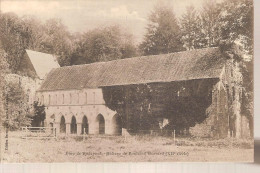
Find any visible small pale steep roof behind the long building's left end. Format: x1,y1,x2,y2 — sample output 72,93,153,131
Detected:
26,50,60,79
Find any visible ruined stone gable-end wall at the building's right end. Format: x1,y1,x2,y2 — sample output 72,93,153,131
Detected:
190,59,250,138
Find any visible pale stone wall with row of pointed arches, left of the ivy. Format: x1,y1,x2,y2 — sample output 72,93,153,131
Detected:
37,89,122,135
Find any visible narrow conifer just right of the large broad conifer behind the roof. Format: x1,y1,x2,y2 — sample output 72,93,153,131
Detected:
180,6,204,50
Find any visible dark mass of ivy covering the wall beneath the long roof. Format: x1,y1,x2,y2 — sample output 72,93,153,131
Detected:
102,79,216,133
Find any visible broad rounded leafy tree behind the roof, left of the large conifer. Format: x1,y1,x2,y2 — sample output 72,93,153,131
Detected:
71,26,136,64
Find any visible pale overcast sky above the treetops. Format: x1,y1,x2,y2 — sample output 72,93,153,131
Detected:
0,0,210,42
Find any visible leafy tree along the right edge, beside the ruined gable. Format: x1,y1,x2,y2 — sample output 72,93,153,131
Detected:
219,0,254,136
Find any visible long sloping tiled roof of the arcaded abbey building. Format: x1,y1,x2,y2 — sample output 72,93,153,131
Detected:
39,48,225,91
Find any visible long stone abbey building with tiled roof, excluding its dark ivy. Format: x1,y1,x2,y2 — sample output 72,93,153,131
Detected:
33,48,250,138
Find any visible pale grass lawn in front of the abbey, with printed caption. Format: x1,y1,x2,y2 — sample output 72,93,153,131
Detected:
1,132,254,163
